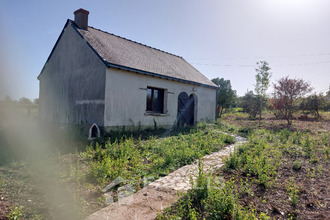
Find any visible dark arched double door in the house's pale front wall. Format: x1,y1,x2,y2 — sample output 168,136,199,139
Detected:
177,92,195,127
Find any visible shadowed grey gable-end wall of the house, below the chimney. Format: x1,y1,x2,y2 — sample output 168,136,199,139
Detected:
39,23,106,126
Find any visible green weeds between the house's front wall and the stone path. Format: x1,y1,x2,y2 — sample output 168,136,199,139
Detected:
81,128,234,185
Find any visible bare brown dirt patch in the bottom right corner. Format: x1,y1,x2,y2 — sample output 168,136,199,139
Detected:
221,152,330,220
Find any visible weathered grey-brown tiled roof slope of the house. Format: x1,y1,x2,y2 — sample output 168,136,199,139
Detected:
71,21,216,87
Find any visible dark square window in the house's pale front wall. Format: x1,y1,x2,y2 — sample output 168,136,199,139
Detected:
147,87,164,113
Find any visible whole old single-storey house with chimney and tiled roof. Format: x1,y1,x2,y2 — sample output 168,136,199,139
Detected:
38,9,217,137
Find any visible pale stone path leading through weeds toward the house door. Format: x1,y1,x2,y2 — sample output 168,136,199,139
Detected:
87,136,246,220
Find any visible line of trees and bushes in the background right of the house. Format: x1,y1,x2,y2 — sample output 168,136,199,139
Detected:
212,61,330,125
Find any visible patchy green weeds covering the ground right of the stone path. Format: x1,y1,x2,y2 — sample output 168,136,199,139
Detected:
157,123,330,219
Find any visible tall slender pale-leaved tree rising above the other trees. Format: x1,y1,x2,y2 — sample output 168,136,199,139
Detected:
254,61,272,126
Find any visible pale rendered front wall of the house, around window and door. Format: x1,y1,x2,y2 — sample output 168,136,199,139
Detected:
104,68,216,128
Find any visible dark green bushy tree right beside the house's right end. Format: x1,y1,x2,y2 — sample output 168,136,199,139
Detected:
212,77,237,118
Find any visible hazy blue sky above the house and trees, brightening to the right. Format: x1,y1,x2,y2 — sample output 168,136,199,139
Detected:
0,0,330,99
